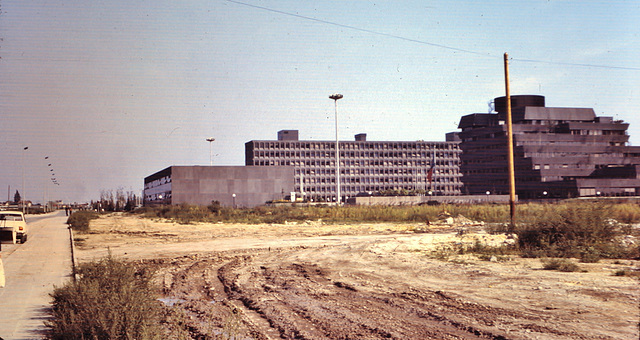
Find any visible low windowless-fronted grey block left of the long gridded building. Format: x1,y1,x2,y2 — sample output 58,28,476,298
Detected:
144,166,294,208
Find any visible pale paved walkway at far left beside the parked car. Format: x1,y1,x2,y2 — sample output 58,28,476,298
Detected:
0,211,71,340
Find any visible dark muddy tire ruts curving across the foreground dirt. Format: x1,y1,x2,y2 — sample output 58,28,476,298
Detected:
158,249,576,339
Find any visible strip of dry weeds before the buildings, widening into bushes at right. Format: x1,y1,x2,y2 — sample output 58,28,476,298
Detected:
138,202,640,263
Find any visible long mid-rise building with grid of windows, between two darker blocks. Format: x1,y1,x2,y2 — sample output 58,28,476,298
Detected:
245,130,462,202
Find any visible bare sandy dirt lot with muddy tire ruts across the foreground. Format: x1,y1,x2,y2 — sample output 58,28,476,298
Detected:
76,214,640,339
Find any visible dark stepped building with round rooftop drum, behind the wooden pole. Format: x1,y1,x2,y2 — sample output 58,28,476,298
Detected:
449,95,640,198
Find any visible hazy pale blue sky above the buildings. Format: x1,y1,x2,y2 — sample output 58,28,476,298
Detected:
0,0,640,201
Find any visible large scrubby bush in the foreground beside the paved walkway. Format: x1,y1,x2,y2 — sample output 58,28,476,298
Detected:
45,257,164,340
